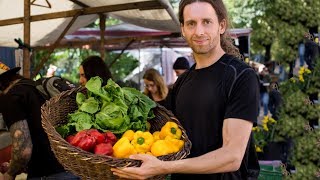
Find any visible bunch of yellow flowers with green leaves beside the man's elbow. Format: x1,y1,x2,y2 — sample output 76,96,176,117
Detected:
252,116,277,152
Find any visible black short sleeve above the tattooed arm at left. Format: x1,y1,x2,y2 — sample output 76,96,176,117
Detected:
2,95,27,128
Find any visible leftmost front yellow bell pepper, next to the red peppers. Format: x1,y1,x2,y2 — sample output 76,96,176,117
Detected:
113,137,137,158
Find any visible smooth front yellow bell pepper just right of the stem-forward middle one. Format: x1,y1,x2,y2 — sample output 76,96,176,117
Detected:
151,140,174,156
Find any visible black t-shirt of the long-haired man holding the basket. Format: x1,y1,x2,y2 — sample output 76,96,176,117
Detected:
172,55,259,180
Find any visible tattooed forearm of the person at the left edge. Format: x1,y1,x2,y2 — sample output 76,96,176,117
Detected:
7,120,32,176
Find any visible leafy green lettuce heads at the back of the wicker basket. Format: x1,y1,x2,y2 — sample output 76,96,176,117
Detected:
56,77,156,137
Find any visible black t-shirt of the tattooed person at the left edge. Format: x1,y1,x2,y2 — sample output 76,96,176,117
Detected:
1,79,64,178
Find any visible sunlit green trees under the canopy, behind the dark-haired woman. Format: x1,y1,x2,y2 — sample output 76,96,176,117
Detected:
32,48,139,83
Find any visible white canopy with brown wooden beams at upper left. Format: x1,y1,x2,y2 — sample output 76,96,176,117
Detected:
0,0,179,77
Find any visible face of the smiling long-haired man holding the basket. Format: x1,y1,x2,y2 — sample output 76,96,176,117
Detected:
181,2,226,54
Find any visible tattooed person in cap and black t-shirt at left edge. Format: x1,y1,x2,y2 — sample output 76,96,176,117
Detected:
0,62,79,179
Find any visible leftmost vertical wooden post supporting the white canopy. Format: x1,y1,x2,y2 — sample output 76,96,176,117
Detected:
23,0,30,78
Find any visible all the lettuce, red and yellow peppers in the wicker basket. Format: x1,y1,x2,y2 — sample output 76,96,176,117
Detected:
56,77,184,158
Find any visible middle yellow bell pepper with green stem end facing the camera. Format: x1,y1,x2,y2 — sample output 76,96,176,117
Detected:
131,131,153,153
